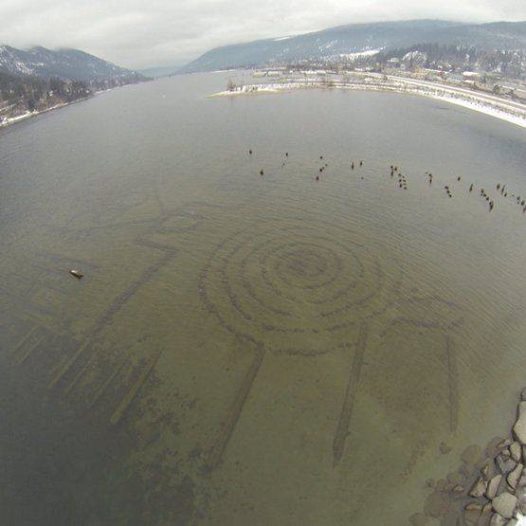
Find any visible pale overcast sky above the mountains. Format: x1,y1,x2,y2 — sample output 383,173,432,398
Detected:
0,0,526,68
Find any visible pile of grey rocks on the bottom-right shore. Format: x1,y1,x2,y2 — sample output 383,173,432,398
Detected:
410,389,526,526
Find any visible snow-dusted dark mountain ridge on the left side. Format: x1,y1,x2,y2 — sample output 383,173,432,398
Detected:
0,45,146,84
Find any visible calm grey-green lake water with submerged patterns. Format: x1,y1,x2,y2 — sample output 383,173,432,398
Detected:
0,74,526,526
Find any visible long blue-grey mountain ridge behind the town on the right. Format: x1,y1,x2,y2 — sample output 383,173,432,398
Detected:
179,20,526,73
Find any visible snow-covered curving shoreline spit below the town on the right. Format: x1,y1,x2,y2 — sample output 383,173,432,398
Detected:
212,75,526,128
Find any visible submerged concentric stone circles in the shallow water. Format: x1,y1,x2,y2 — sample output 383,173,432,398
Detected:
200,218,400,355
